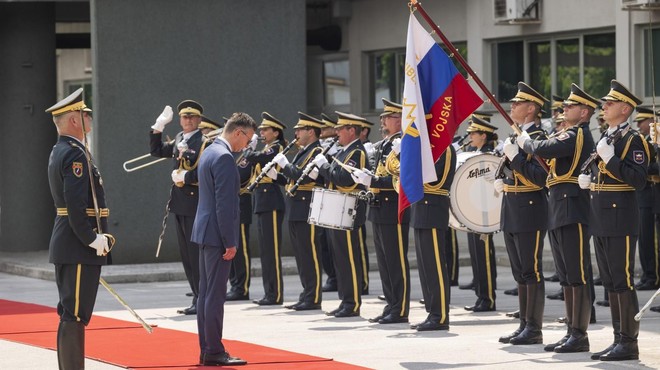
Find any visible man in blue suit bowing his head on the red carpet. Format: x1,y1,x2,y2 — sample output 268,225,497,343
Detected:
192,113,257,366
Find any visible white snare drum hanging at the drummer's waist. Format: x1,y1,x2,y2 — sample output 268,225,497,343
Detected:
307,188,357,230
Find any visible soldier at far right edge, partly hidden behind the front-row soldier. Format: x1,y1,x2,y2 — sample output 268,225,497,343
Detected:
633,107,660,290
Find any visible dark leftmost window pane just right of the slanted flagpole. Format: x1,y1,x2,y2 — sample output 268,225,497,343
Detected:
496,41,525,102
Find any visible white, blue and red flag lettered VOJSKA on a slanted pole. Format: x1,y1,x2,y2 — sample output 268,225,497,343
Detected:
399,13,483,218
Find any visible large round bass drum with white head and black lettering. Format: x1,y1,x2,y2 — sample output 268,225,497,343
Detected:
449,152,502,234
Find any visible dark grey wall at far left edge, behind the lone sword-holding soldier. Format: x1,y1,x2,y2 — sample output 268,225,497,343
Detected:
0,2,57,252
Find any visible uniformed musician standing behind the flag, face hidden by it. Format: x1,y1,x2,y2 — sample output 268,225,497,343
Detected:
385,132,456,331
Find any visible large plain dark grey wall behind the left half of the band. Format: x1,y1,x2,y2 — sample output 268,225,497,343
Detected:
91,0,306,263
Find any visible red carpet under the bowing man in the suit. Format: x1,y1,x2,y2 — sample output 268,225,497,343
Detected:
0,300,364,370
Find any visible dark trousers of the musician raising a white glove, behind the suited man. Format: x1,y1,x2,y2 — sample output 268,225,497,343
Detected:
176,215,199,304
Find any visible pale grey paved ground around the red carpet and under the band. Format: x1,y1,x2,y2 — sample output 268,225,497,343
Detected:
0,250,660,370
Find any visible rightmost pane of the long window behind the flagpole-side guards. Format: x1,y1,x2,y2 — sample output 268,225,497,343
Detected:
582,33,616,99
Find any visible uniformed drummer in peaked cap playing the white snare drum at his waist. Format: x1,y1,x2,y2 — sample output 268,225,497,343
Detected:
312,112,370,317
